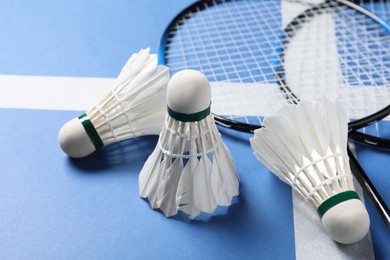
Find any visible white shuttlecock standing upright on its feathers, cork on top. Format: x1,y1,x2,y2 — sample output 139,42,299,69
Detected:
139,70,239,219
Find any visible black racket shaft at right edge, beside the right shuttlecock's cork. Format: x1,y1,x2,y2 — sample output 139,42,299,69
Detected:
347,147,390,228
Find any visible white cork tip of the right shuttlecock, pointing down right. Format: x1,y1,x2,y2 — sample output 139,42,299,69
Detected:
322,199,370,244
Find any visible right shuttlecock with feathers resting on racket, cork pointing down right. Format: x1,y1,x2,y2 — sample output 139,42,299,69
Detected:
250,98,370,244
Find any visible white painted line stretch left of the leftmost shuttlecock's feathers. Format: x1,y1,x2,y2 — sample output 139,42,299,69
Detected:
0,75,115,111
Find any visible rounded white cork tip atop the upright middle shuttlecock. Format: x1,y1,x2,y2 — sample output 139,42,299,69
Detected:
167,70,211,114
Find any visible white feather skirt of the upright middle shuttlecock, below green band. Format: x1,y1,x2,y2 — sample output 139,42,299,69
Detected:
139,116,239,219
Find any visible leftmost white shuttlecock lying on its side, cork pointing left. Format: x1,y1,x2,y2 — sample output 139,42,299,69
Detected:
58,48,169,158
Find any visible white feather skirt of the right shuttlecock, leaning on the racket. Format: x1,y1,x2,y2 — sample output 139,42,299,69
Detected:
251,98,351,206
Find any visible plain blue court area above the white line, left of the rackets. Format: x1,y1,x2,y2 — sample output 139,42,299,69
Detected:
0,0,192,77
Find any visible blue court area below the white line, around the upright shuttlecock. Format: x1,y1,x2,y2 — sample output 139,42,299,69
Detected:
0,109,294,259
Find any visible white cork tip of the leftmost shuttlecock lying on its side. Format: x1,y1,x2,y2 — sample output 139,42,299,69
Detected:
58,118,96,158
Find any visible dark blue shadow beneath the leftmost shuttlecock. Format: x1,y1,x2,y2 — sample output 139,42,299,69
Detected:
69,136,158,172
